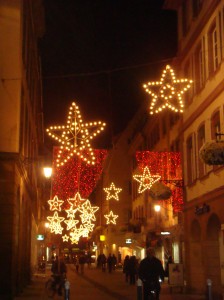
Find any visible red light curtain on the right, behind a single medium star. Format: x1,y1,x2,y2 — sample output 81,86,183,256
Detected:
136,151,183,213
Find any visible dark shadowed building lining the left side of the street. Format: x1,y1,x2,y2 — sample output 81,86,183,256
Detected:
0,0,44,299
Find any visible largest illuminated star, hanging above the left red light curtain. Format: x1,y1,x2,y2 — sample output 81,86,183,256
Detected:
47,102,106,167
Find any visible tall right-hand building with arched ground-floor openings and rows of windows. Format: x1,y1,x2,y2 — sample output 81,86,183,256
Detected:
164,0,224,299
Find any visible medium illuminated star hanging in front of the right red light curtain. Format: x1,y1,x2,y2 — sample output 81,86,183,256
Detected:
133,167,161,193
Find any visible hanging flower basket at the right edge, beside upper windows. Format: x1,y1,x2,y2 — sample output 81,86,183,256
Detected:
199,140,224,165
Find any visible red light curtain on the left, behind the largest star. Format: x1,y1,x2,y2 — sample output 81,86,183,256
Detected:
52,147,108,203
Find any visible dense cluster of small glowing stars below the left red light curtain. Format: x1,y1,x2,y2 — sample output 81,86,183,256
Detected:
47,193,99,244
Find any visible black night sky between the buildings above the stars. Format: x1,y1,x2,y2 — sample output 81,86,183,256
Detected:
40,0,176,147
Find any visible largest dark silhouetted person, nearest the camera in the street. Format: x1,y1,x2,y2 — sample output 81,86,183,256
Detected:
138,248,165,300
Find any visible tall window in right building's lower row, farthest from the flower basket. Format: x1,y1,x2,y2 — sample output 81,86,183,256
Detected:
187,135,196,184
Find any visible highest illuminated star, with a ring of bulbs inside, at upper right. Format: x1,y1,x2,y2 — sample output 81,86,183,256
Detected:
143,65,193,114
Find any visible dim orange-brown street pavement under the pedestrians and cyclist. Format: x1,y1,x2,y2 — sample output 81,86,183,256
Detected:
15,264,205,300
